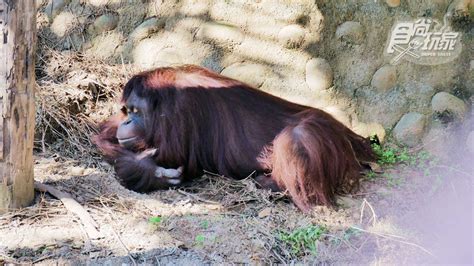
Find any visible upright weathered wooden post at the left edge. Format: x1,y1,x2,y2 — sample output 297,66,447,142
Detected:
0,0,36,213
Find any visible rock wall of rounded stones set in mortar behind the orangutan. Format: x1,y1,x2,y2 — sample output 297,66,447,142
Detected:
37,0,474,150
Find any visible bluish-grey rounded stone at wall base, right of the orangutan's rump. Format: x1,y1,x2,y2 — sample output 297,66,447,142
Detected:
393,112,426,147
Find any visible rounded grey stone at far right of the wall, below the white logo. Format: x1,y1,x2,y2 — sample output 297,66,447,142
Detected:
431,91,467,119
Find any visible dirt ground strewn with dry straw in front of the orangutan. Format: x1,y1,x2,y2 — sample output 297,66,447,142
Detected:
0,143,472,265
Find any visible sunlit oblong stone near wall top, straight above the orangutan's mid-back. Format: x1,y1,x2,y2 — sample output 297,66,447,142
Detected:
196,22,244,44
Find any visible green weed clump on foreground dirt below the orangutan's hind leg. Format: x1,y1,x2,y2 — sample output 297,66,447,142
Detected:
278,225,327,255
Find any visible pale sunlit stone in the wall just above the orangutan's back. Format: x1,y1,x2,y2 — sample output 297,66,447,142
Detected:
221,62,269,88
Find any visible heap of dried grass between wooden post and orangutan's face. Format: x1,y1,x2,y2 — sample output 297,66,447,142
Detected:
35,42,133,160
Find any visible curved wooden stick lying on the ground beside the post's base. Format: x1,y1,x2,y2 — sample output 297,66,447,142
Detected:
35,182,103,239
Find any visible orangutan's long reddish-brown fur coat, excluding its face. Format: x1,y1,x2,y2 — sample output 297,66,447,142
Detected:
94,66,374,211
